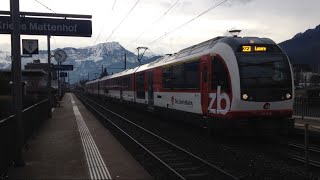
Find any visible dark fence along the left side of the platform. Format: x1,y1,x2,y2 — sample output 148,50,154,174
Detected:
0,99,49,179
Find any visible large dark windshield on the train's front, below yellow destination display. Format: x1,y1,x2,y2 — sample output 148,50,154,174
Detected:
237,53,292,101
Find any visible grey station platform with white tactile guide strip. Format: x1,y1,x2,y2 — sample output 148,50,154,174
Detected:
8,93,152,179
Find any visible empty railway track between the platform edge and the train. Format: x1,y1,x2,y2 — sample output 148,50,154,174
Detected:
76,94,238,179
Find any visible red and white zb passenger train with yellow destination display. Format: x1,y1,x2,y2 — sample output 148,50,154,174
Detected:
84,36,294,130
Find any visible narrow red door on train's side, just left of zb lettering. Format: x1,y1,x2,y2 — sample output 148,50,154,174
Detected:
200,58,209,115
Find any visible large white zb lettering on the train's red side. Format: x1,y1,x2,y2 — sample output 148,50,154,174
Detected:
208,86,230,115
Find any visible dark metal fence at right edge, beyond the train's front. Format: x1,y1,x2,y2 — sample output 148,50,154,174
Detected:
293,97,320,117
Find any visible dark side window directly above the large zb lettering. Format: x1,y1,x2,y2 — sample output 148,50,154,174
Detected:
211,57,230,93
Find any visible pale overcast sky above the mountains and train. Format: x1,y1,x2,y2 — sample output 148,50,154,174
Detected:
0,0,320,54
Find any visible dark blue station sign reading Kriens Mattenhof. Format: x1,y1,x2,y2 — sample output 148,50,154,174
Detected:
0,16,92,37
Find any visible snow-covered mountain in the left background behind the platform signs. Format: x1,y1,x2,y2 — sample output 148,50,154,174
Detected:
0,42,159,83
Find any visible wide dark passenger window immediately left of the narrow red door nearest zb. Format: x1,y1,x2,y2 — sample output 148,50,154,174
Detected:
162,61,200,89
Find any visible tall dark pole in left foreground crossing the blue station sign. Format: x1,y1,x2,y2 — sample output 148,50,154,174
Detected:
10,0,25,166
